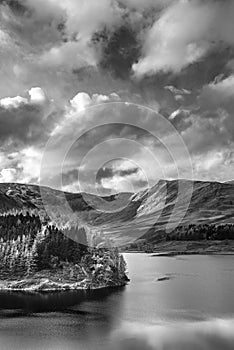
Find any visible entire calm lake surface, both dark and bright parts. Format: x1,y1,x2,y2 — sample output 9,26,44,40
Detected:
0,254,234,350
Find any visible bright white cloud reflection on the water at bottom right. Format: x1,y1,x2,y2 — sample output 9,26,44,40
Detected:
113,319,234,350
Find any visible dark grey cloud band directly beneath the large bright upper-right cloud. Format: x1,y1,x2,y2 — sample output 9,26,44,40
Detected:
136,45,234,108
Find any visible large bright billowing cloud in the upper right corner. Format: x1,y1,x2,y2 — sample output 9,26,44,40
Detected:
133,0,234,76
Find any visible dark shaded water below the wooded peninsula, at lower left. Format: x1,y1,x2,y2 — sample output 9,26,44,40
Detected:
0,287,125,350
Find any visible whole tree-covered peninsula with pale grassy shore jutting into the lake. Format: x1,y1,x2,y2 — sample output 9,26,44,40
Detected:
0,212,128,292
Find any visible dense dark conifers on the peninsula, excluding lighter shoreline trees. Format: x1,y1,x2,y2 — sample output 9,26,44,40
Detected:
0,213,87,276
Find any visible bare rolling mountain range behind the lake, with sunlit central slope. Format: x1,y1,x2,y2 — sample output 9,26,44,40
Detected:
0,180,234,244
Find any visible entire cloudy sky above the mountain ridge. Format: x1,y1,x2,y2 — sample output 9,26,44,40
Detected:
0,0,234,195
